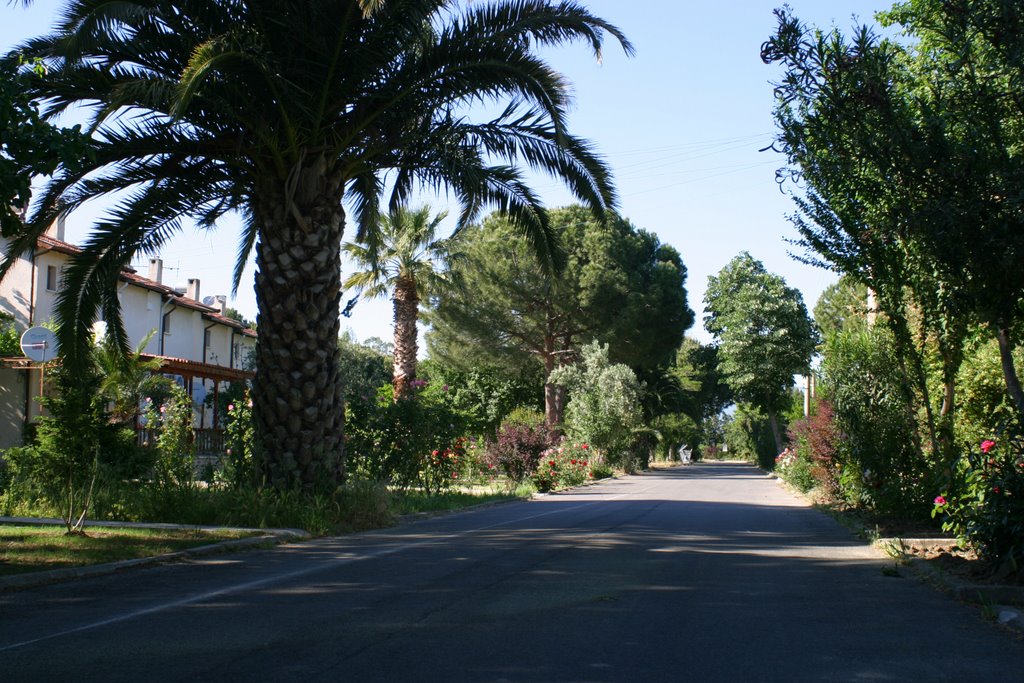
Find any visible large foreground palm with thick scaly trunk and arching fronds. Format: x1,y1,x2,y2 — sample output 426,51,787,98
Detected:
0,0,632,489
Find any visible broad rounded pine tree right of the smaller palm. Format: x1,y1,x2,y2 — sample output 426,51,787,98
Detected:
427,206,693,428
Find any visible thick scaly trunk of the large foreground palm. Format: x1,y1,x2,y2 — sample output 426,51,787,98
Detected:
252,169,345,492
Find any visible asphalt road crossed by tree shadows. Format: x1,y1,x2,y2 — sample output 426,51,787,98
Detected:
0,463,1024,683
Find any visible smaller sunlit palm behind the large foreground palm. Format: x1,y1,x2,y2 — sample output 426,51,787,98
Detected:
343,205,463,400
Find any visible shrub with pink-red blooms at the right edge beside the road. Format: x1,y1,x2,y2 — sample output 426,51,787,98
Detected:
932,424,1024,572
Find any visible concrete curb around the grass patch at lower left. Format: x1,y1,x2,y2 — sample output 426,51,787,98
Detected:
0,517,312,592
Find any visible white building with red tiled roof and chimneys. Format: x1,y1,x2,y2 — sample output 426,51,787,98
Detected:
0,223,256,451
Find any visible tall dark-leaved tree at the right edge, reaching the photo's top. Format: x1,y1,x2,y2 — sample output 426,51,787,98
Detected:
763,0,1024,428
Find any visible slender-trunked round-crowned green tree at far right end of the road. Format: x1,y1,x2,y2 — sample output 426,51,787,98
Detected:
703,252,818,453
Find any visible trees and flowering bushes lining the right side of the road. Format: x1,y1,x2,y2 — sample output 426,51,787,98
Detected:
757,0,1024,580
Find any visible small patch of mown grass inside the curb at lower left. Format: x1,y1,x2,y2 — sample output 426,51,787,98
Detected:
0,525,258,577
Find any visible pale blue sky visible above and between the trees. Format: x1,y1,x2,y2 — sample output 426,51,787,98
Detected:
0,0,889,348
